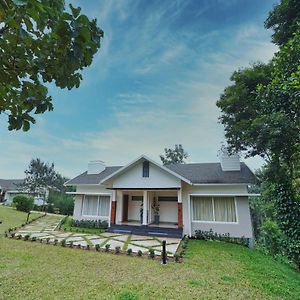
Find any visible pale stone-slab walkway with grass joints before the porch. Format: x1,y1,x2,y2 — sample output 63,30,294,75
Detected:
16,215,180,256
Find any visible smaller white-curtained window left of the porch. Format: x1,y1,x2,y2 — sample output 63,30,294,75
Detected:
82,195,110,217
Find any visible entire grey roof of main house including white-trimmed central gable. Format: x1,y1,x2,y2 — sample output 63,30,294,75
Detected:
65,155,256,186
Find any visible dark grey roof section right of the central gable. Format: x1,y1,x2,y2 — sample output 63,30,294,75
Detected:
166,163,256,184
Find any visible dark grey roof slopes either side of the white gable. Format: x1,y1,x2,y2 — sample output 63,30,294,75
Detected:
66,163,256,185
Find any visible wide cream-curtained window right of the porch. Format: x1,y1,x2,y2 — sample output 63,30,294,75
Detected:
192,196,237,223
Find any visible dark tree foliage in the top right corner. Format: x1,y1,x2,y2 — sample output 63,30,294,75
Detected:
265,0,300,46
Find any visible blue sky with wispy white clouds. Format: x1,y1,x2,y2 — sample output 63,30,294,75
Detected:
0,0,278,178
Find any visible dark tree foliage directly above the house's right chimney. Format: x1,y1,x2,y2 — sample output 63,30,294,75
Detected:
217,63,271,156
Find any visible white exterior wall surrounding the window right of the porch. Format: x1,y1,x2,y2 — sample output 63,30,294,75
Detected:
182,184,253,238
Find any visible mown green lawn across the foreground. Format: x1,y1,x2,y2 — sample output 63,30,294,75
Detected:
0,207,300,300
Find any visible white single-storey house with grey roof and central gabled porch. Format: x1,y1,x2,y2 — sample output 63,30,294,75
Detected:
65,155,256,238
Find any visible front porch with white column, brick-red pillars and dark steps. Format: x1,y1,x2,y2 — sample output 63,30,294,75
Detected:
109,188,183,237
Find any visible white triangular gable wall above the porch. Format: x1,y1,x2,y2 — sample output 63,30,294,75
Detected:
113,163,181,189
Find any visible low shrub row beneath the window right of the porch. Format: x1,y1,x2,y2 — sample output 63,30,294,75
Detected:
194,229,248,246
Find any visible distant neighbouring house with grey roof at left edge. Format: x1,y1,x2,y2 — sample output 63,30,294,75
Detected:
0,179,43,206
